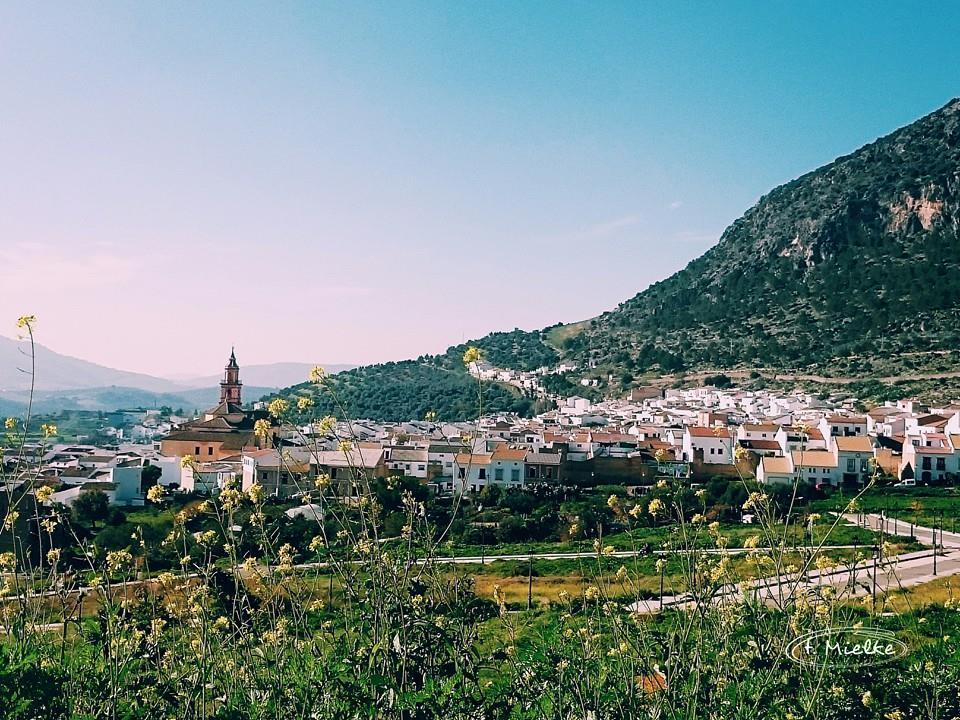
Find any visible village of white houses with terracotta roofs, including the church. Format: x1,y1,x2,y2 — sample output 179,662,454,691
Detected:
6,354,960,507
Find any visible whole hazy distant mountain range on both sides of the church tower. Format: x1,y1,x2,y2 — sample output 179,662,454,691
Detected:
0,336,351,416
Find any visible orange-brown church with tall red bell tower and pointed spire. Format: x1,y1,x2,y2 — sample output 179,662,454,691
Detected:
160,348,276,462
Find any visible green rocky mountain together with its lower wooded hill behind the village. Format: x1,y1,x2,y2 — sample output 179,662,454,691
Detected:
268,99,960,420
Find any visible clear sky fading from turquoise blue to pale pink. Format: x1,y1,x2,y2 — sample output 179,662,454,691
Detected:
0,0,960,376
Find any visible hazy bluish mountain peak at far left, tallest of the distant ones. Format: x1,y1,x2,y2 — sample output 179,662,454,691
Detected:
0,336,183,393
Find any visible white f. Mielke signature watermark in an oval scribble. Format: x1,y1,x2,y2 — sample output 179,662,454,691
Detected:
786,627,909,668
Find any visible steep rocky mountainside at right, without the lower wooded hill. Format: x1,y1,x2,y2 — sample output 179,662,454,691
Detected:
568,100,960,369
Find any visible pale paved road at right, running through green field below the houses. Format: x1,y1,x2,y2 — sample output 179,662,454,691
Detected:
631,514,960,613
